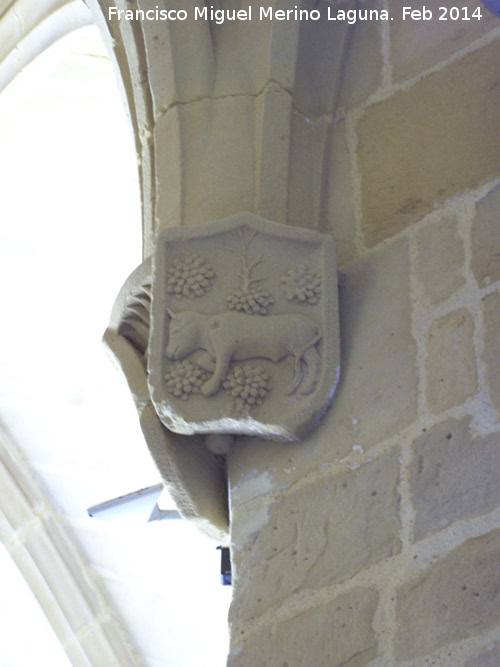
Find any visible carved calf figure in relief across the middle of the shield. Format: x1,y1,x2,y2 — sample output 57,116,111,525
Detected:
165,311,322,396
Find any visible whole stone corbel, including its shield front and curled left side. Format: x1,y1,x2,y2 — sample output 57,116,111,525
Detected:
104,213,339,542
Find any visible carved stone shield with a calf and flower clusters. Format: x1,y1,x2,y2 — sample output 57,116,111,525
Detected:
149,213,340,440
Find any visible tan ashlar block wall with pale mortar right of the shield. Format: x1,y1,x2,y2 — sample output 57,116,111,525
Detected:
228,6,500,667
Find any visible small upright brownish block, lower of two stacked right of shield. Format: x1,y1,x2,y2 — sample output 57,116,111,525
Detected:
427,308,477,414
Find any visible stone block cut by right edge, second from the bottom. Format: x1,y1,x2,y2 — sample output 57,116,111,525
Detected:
396,530,500,660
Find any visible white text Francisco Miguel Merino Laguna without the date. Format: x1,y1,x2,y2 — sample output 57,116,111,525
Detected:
108,5,390,24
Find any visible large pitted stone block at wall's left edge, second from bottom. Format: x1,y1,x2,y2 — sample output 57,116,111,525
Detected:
231,452,400,620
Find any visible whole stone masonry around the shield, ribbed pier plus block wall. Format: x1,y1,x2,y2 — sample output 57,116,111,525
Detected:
88,0,500,667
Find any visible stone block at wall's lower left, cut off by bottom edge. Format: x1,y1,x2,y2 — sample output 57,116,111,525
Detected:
228,588,378,667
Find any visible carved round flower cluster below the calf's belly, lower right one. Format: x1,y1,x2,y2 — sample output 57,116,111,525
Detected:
222,364,271,414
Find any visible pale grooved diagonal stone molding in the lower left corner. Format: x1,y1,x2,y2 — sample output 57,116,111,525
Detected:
0,426,139,667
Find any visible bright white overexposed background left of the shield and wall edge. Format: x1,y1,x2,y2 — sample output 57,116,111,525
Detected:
0,27,230,667
